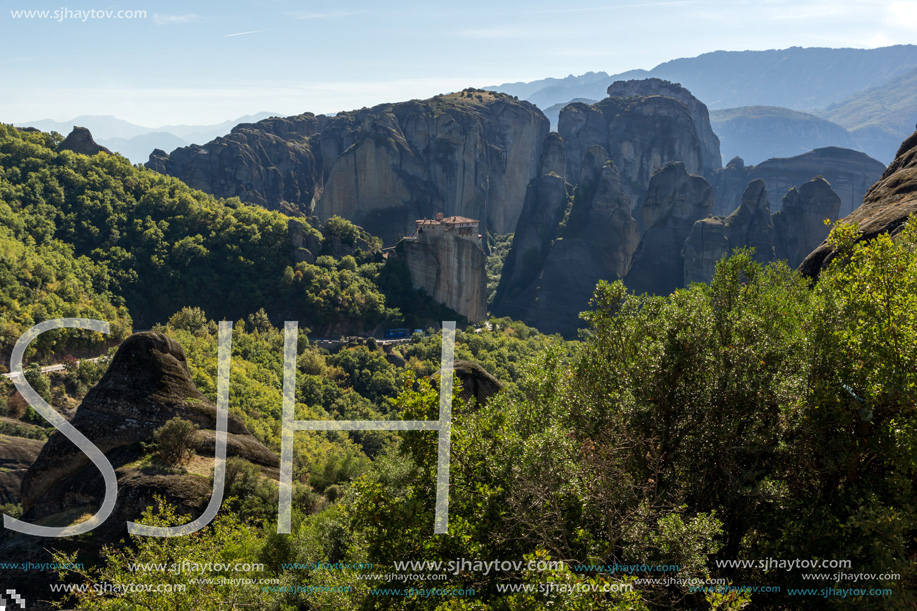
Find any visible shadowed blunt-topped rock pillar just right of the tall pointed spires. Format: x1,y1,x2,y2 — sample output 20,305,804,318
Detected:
624,163,713,295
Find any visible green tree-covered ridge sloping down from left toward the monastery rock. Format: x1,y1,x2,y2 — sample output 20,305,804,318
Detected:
0,126,446,364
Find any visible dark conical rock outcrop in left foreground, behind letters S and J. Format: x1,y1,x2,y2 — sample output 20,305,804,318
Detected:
22,332,279,533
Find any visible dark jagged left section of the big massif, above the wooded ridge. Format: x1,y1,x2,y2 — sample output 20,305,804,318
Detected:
146,113,328,214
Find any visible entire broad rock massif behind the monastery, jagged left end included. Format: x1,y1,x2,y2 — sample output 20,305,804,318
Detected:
147,90,548,244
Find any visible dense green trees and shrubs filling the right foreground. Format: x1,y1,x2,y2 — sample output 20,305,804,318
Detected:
52,221,917,610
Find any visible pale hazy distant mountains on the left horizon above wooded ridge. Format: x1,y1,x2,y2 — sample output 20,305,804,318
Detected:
16,112,277,163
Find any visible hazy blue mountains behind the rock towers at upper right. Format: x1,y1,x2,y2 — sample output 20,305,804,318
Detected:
486,45,917,164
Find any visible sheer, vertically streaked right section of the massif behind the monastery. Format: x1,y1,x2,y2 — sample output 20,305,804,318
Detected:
315,90,548,242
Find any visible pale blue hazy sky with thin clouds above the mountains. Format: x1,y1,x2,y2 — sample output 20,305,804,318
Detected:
0,0,917,127
